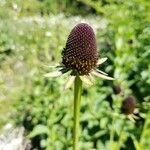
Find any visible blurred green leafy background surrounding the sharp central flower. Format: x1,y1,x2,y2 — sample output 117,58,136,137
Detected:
0,0,150,150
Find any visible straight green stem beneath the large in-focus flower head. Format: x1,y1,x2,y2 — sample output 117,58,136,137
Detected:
73,76,82,150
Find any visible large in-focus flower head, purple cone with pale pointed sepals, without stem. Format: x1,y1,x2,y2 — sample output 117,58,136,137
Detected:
45,23,113,88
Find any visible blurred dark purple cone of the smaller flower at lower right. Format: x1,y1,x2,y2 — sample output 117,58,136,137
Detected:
121,96,136,115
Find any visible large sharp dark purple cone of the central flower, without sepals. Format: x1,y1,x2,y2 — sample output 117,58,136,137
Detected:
62,23,98,75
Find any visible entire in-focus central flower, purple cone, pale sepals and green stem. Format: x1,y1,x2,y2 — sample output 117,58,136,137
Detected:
44,23,114,150
